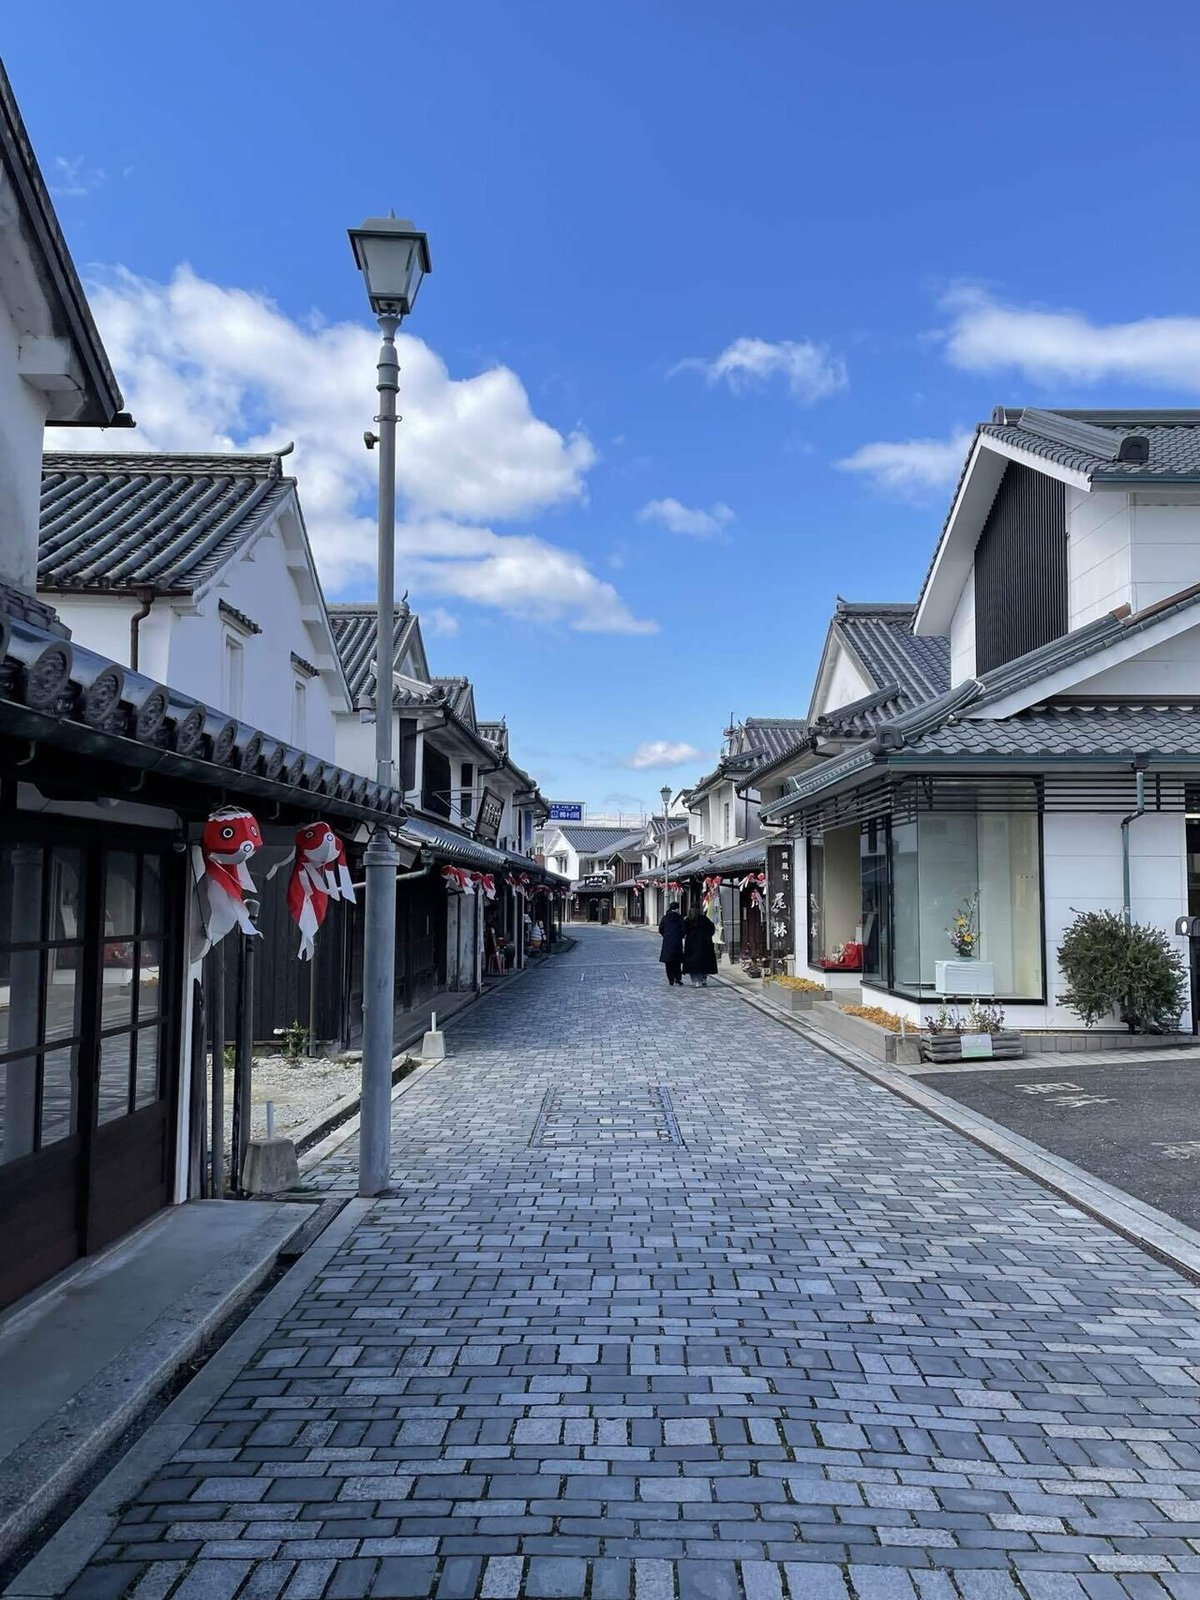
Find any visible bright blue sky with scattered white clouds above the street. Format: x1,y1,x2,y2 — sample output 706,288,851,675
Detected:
5,0,1200,810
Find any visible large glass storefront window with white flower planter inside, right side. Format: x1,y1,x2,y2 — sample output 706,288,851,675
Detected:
808,797,1045,1003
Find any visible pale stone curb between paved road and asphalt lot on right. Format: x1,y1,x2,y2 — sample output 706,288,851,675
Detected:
722,982,1200,1282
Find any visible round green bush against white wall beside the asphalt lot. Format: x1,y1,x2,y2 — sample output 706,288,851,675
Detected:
1058,910,1187,1034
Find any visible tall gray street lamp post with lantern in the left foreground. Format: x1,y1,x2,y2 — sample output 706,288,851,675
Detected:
350,216,430,1197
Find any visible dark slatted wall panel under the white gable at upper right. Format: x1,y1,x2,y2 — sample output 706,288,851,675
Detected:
974,461,1067,672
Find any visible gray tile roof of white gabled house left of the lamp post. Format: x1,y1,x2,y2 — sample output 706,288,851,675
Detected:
37,453,296,594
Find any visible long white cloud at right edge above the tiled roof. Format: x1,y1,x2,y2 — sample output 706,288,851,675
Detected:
944,286,1200,392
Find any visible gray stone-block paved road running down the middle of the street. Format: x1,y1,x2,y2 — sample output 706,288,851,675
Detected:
56,928,1200,1600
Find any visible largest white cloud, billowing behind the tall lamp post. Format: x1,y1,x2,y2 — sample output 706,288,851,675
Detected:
48,266,654,634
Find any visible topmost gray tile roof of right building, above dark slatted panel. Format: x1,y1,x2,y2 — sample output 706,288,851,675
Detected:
979,406,1200,483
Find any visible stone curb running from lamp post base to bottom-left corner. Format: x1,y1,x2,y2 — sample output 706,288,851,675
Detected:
5,1200,374,1600
